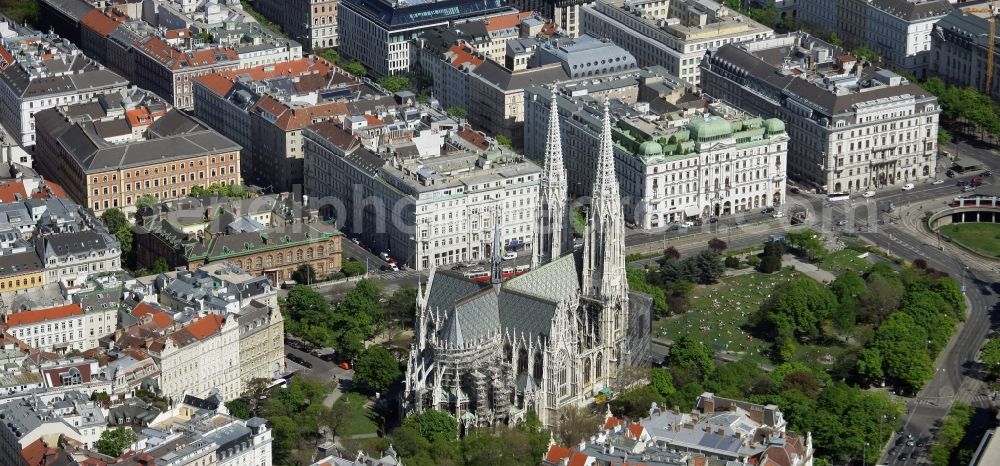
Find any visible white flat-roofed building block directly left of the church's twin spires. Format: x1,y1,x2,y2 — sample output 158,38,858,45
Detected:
305,121,540,270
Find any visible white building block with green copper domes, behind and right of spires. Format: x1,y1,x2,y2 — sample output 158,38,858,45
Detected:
525,73,789,229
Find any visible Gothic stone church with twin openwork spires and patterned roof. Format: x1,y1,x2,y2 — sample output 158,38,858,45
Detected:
403,96,651,429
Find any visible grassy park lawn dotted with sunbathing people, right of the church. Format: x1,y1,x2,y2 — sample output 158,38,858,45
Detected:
653,269,797,356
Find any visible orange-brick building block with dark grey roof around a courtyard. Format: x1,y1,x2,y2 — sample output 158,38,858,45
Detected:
35,90,242,213
